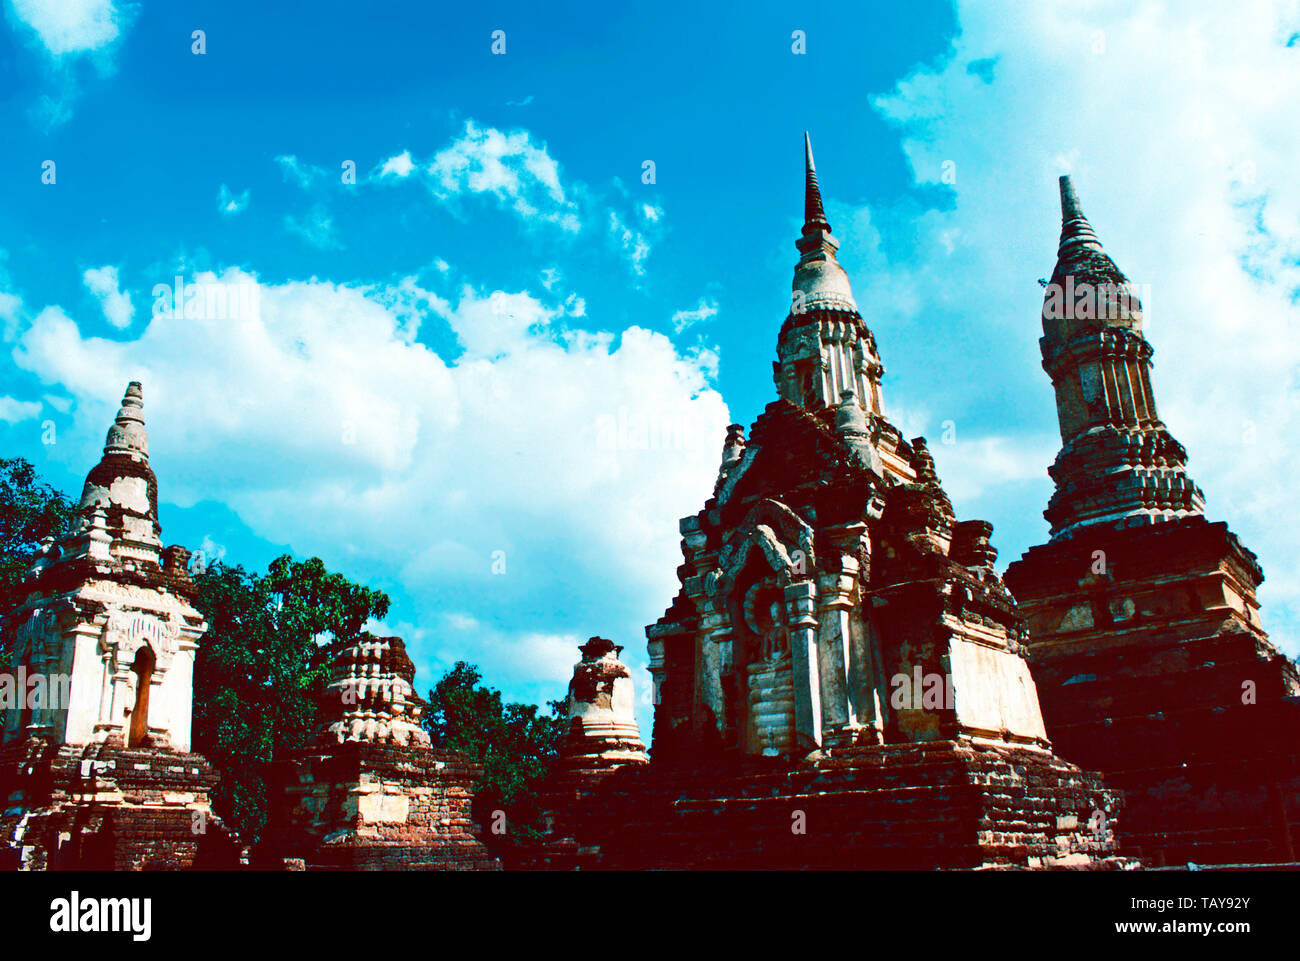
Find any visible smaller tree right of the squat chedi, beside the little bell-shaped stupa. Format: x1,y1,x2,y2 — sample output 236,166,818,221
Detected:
424,661,564,843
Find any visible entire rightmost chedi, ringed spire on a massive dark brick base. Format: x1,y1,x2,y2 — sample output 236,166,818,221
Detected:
1006,177,1300,863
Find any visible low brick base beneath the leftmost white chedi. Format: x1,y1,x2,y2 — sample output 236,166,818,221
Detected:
0,737,241,871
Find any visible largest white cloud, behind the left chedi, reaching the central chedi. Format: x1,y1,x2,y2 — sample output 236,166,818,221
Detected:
7,269,728,712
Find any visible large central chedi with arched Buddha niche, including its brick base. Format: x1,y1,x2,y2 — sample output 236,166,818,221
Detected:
527,137,1121,869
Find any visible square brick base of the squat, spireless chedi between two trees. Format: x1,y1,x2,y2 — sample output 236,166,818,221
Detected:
255,741,501,871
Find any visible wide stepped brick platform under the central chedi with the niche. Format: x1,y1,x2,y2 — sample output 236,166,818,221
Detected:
520,740,1128,870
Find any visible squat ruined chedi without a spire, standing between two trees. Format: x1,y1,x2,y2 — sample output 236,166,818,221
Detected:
255,635,501,870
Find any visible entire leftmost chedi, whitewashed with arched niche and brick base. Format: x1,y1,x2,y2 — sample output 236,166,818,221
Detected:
0,382,237,870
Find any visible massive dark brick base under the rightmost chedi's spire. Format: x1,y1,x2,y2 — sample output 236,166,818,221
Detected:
1006,518,1300,865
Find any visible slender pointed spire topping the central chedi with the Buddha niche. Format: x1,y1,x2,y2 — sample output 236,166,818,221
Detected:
772,133,884,415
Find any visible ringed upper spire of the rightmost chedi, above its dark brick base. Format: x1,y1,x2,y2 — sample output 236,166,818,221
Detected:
1040,177,1205,540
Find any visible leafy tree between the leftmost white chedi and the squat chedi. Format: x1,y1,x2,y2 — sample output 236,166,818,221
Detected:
194,555,389,841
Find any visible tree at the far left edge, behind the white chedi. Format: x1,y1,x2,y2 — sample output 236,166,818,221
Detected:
0,458,77,614
